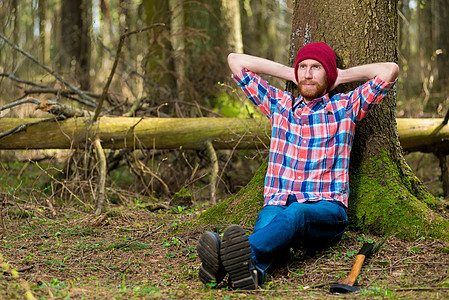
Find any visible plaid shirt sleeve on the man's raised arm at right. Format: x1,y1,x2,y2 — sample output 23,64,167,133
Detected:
347,76,396,122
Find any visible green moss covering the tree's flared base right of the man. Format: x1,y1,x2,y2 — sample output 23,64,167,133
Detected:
349,151,449,240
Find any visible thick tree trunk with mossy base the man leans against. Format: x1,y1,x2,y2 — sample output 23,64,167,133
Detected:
201,0,449,239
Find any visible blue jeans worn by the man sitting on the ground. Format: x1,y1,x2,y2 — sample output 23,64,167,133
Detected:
248,195,348,281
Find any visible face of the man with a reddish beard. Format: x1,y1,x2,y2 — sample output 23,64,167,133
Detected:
298,59,328,102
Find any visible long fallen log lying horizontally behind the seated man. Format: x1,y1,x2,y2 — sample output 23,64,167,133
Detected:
0,117,449,152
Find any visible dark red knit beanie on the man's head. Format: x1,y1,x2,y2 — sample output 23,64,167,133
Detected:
295,42,337,90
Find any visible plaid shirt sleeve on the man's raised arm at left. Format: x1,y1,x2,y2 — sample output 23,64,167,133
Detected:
232,69,284,118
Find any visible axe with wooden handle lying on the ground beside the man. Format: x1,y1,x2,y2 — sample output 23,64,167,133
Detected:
330,243,377,294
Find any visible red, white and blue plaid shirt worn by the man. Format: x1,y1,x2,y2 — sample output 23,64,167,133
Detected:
233,69,395,207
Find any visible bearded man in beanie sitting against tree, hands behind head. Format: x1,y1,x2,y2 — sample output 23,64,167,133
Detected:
197,42,399,290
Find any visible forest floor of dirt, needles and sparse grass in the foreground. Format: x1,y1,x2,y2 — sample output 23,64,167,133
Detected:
0,203,449,299
